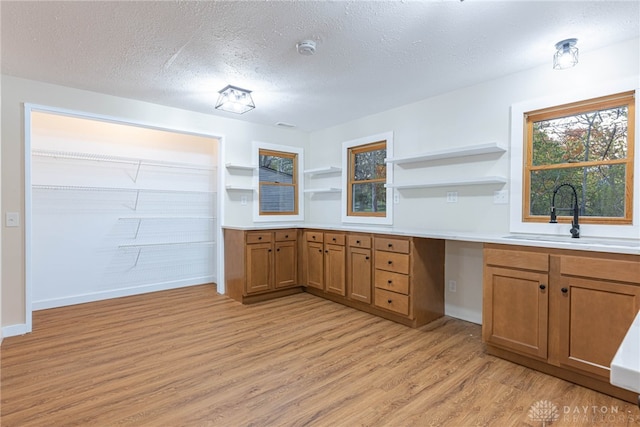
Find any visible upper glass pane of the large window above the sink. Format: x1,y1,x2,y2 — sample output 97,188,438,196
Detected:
532,106,628,166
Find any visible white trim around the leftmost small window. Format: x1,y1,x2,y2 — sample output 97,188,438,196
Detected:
252,141,304,222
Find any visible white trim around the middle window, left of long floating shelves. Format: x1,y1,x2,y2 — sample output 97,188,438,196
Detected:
342,132,394,225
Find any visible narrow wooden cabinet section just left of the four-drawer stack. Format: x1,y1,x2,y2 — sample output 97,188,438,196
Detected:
347,234,373,304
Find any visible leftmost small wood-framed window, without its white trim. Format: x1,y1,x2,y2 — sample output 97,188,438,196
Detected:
258,149,298,215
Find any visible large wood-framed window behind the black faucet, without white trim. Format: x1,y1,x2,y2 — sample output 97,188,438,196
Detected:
522,92,635,224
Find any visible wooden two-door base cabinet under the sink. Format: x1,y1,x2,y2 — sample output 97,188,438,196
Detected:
482,244,640,402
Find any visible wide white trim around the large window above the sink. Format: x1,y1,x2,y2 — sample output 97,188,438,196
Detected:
509,78,640,239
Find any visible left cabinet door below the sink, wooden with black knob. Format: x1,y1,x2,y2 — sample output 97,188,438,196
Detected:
482,267,549,359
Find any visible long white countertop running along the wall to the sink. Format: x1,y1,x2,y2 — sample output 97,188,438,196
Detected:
222,223,640,255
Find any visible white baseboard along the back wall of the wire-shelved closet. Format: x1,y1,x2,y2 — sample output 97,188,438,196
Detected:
31,276,216,310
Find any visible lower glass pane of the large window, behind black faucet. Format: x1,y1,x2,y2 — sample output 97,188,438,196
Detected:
530,164,626,218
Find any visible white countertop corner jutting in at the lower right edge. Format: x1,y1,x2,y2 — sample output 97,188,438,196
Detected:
610,312,640,393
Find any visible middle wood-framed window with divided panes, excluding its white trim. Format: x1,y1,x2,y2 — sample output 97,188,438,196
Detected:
347,141,387,216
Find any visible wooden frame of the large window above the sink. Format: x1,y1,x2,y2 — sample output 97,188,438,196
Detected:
522,91,636,225
